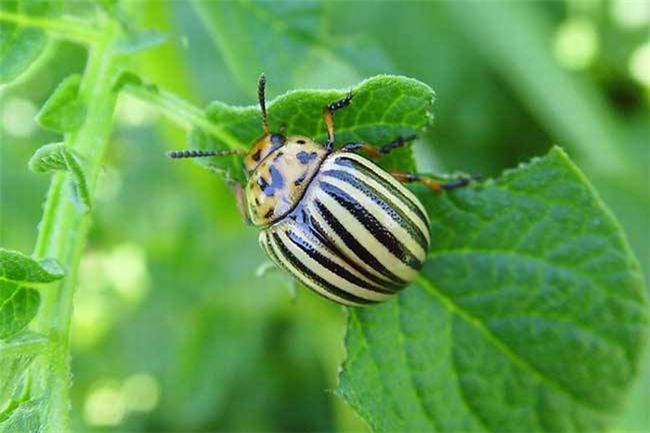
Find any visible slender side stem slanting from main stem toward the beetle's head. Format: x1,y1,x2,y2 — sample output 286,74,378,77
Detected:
123,84,248,150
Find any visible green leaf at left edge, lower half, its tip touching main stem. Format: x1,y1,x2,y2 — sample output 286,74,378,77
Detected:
0,249,63,339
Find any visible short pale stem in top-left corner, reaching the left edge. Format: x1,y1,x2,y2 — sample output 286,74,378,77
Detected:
0,10,100,45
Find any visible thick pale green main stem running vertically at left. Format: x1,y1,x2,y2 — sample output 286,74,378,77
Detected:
34,23,119,433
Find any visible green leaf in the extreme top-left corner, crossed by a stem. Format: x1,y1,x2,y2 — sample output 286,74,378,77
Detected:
0,0,59,83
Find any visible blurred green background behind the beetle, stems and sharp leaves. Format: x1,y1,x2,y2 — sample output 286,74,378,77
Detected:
0,0,650,432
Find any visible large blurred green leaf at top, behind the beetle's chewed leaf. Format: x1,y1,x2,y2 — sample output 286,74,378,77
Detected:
192,0,395,91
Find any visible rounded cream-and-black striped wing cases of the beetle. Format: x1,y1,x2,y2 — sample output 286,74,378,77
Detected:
260,152,429,305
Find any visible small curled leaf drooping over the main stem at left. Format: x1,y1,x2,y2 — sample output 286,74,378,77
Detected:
28,143,91,210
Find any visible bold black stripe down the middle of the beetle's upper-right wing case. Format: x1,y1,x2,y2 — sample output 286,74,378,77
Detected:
319,181,422,270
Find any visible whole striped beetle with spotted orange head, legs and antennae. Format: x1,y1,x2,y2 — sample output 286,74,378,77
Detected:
168,74,471,306
